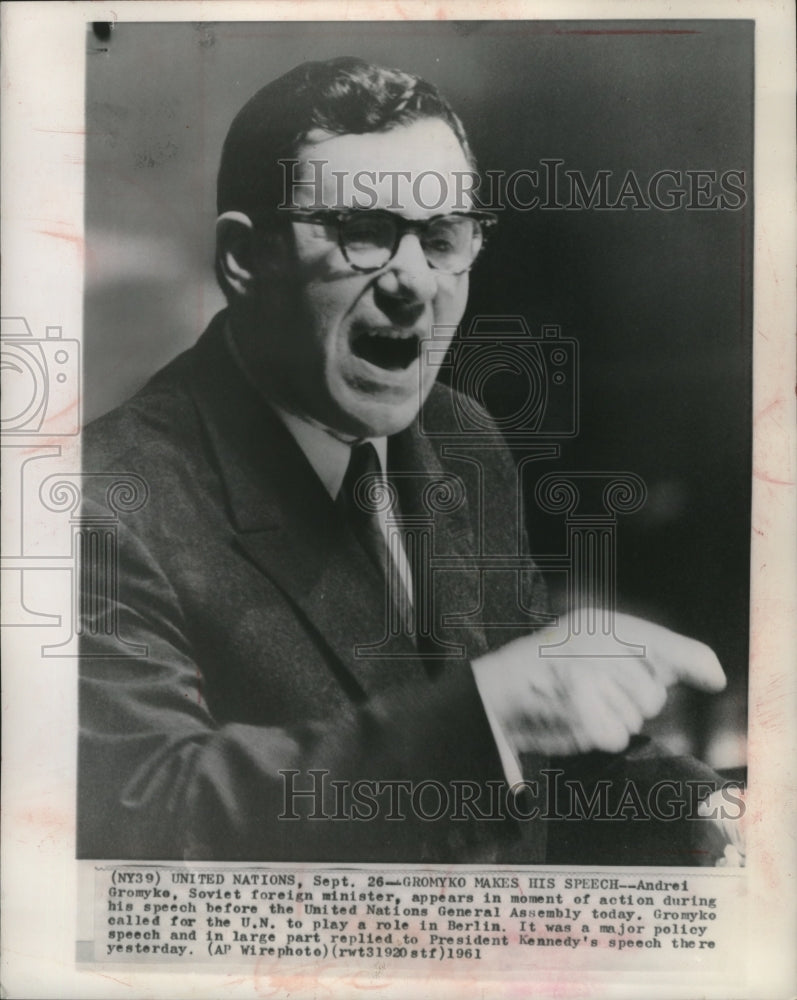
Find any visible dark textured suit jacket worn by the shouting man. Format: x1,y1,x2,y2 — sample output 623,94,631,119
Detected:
78,316,728,864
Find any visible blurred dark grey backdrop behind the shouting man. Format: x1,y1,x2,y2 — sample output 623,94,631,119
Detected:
84,21,753,766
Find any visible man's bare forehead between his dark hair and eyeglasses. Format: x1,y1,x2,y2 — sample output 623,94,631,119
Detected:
292,118,474,217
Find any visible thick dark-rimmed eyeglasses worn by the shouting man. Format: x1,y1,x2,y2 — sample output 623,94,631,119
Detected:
285,209,498,274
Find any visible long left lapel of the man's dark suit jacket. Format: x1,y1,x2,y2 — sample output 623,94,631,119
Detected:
185,317,424,697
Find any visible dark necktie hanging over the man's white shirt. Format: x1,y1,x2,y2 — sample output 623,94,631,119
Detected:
337,441,412,633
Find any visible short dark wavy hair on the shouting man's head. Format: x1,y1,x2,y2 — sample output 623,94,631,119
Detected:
216,56,476,218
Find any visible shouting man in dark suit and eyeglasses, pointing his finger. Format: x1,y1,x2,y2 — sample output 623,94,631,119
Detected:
78,59,736,864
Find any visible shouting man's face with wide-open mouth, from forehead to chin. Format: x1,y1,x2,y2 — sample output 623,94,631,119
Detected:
252,119,470,437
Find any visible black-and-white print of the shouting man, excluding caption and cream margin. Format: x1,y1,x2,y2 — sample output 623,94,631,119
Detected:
78,21,753,866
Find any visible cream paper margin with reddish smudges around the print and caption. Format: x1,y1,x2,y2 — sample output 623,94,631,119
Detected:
2,0,797,1000
